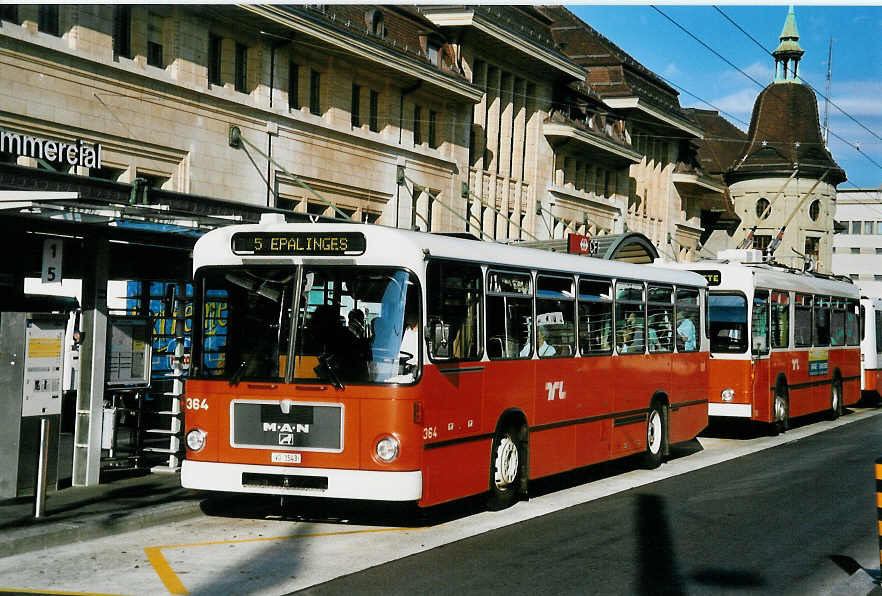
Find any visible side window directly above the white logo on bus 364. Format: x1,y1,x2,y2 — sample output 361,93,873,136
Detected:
535,275,576,358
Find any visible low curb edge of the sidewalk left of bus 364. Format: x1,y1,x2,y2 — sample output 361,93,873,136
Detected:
0,500,202,557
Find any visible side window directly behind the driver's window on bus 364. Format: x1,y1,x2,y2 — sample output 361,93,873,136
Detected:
486,270,533,360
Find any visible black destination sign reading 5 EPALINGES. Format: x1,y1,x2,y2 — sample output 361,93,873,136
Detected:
232,232,367,257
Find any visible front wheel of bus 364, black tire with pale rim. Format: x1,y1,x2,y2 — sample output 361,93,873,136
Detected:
487,425,527,511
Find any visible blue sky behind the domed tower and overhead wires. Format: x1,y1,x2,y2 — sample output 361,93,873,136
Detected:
567,2,882,190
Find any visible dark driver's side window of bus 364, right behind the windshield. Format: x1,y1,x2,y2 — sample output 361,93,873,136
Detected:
426,260,482,360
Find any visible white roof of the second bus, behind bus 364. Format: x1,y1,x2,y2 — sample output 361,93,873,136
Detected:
668,260,860,298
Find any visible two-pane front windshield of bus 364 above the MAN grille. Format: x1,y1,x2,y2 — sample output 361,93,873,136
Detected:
194,266,420,386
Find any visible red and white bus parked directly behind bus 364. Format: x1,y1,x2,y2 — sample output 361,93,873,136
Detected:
680,250,861,431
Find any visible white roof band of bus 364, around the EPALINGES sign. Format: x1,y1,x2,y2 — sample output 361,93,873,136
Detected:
193,223,707,287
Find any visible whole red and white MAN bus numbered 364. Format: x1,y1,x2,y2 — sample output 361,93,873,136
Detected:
181,216,708,508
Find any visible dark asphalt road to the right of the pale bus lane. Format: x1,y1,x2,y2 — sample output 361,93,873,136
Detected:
298,417,882,595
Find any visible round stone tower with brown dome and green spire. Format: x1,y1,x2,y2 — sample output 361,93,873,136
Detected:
724,6,846,273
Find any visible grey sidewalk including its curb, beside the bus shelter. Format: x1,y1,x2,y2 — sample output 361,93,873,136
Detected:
0,472,206,557
